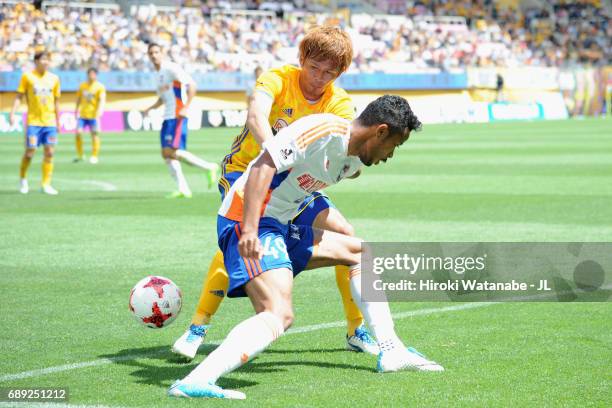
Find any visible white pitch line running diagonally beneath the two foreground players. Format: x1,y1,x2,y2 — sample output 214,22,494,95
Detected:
0,302,496,383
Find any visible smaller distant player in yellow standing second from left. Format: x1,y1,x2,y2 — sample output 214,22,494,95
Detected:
74,68,106,164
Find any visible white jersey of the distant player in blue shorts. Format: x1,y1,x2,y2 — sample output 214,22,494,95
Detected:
155,61,193,119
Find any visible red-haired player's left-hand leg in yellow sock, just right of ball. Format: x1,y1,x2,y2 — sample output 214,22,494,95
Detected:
172,171,242,360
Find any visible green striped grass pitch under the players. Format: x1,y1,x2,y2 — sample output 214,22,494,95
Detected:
0,119,612,407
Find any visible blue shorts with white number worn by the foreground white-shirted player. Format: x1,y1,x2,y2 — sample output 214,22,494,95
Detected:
217,215,314,297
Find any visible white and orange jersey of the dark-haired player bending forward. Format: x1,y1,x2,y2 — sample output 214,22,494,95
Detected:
219,113,362,223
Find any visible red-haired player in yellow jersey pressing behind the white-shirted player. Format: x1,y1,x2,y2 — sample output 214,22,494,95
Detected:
172,26,379,359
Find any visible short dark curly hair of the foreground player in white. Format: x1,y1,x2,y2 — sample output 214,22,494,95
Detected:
357,95,423,135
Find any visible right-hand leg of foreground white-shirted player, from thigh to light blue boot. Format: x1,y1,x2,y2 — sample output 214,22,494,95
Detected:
301,227,444,372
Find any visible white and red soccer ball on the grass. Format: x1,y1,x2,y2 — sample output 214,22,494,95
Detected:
130,276,183,329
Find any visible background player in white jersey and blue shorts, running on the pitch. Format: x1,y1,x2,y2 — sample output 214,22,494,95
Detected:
143,43,219,198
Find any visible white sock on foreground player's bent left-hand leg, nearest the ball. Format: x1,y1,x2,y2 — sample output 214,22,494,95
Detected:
183,312,285,384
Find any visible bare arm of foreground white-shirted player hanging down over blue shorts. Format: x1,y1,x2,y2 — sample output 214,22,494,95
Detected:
238,151,276,259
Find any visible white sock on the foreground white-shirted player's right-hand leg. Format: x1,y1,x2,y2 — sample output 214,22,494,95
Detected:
350,265,405,351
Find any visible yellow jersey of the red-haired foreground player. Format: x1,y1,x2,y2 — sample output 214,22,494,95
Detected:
223,65,355,173
